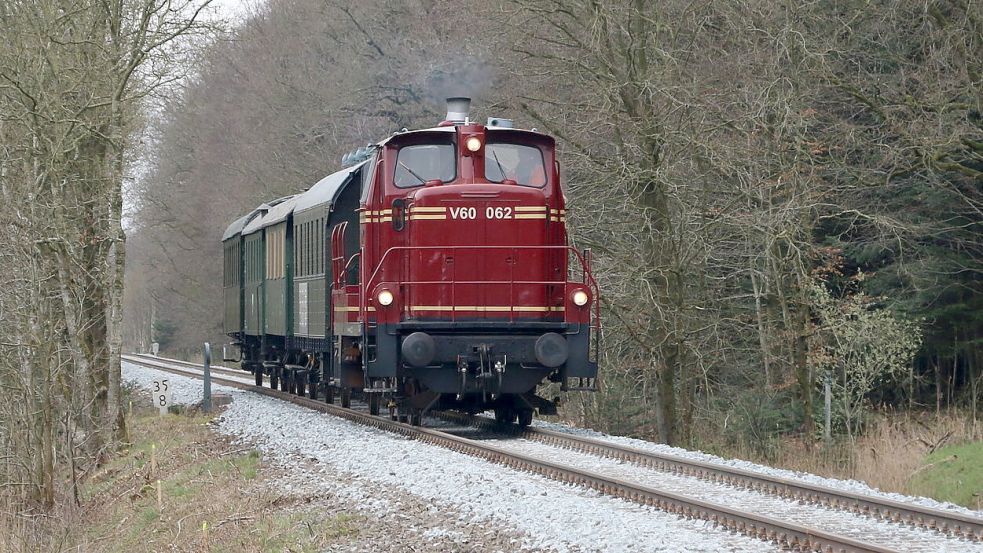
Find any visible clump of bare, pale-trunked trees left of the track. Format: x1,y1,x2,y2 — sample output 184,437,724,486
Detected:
0,0,214,547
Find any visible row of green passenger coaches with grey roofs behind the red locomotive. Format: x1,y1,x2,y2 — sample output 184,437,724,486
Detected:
222,163,367,399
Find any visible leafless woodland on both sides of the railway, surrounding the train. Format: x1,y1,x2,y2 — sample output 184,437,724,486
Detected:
0,0,983,540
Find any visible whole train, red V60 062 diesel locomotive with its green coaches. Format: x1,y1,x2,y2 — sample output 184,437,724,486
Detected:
223,98,600,425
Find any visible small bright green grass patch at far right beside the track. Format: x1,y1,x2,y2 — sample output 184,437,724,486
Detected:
910,441,983,509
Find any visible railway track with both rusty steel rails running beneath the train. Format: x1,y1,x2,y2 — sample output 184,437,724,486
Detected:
124,356,983,552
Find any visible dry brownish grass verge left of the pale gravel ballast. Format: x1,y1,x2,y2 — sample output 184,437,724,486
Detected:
76,402,362,553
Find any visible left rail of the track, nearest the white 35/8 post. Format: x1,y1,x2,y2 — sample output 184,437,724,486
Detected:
123,355,908,553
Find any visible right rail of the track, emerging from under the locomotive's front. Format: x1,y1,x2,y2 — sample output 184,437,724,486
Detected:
440,413,983,541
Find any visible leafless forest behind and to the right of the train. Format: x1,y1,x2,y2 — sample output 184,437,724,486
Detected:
126,0,983,453
